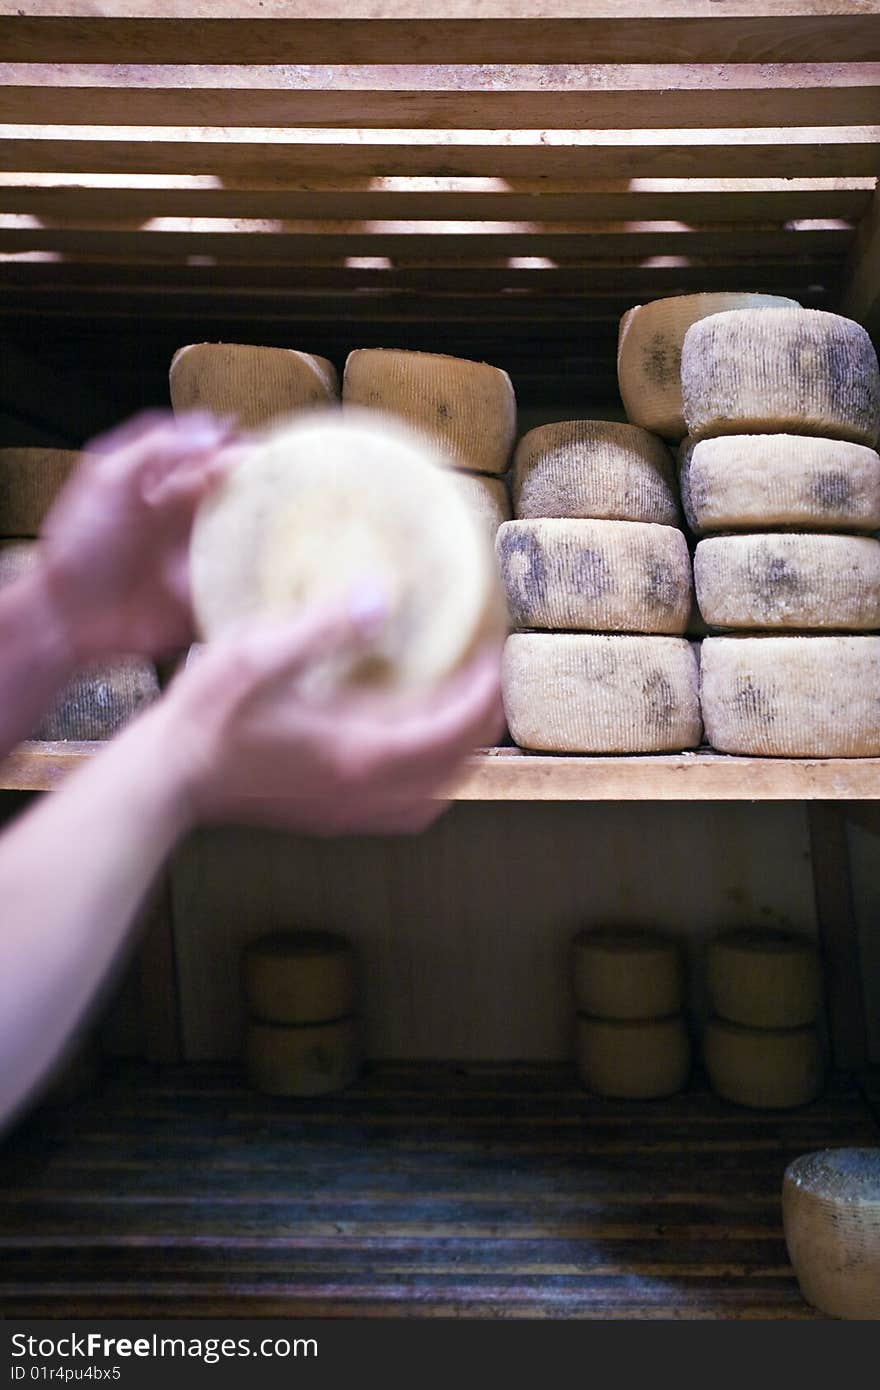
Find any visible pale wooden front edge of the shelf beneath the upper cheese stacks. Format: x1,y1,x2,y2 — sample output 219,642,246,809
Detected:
0,742,880,801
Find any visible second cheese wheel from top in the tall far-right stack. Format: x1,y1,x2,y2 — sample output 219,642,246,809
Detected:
680,434,880,535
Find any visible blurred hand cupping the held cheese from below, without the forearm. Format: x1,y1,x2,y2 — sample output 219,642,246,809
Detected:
164,603,503,835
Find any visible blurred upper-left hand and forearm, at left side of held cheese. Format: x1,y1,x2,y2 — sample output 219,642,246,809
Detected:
0,413,229,758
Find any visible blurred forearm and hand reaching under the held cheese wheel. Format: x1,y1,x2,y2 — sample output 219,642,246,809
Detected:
0,603,500,1125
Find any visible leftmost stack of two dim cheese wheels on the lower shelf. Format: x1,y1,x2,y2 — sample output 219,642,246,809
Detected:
242,931,361,1095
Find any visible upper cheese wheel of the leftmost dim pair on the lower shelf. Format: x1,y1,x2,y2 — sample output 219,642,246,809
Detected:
242,931,357,1023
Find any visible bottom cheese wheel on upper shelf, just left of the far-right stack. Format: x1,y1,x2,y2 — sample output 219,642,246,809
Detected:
502,632,702,753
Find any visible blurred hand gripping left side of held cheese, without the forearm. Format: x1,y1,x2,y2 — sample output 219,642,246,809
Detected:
40,411,231,662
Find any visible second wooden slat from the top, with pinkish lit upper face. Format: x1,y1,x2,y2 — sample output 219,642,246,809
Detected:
0,63,880,129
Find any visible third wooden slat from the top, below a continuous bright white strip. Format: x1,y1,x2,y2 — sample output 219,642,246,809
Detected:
0,124,880,179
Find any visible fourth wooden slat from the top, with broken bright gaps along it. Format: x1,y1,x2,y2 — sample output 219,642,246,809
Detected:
0,174,876,222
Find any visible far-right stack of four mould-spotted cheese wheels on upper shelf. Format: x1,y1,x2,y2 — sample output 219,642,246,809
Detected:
681,309,880,758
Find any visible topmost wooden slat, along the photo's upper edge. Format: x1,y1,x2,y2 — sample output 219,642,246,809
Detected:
0,0,880,63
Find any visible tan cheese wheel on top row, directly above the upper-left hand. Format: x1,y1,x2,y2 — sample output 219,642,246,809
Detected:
168,343,339,430
